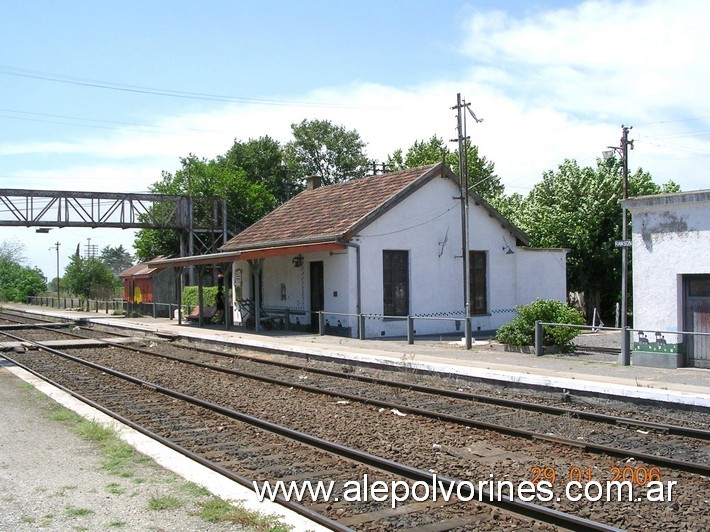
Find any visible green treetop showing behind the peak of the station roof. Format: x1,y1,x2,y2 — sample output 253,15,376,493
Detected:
387,135,504,206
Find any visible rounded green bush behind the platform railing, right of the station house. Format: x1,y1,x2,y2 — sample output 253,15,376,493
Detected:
496,299,584,347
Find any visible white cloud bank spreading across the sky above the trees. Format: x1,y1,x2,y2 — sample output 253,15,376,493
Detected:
0,0,710,203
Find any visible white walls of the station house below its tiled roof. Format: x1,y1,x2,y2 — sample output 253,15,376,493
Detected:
235,172,566,337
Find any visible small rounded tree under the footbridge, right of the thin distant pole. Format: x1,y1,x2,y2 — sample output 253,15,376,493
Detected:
62,255,122,299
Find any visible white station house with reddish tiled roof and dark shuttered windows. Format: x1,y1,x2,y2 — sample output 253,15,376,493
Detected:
221,164,566,337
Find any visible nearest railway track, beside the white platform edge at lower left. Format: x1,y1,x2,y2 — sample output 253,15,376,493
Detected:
4,337,616,530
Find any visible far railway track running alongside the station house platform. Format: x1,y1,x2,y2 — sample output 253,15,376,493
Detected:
54,332,710,475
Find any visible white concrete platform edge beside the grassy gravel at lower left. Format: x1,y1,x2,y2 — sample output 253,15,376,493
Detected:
5,366,328,532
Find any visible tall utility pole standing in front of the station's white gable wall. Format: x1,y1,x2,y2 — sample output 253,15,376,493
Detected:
451,93,482,349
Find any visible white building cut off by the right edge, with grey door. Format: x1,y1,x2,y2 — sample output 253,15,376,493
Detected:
623,190,710,367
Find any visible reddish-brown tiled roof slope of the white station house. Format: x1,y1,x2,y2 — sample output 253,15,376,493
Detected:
220,163,442,251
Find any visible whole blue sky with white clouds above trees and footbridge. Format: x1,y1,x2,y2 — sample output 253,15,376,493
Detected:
0,0,710,279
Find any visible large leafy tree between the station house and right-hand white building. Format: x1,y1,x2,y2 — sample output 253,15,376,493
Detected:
504,158,678,316
